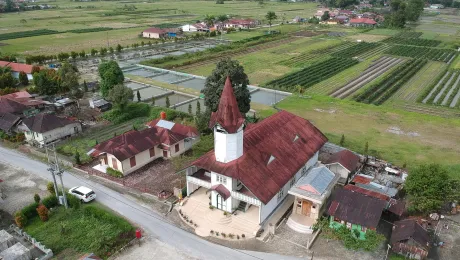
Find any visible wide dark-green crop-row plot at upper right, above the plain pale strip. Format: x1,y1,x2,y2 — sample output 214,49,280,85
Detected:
385,45,456,64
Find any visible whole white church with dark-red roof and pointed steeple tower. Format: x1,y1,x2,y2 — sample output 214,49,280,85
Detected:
186,78,327,225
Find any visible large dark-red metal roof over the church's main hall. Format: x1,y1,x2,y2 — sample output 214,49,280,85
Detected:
192,111,327,204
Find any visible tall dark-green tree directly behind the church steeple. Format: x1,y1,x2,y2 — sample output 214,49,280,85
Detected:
201,58,251,114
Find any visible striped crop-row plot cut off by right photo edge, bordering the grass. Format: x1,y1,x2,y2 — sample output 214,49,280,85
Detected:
422,71,460,108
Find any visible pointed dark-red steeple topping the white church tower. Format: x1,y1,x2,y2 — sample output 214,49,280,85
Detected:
209,76,245,134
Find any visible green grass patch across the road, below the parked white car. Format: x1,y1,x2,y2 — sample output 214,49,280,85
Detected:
24,202,134,259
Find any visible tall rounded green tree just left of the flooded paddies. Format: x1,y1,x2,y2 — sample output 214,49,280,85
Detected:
99,61,125,97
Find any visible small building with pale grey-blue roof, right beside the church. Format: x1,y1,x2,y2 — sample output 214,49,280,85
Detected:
286,166,339,233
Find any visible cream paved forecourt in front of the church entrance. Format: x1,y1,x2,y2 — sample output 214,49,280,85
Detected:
177,187,260,238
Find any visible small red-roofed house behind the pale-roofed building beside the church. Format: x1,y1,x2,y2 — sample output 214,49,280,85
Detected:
324,149,360,185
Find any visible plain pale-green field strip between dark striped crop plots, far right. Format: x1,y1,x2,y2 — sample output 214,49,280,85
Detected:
390,61,447,103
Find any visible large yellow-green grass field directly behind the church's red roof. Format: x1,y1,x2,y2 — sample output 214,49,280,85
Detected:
262,95,460,178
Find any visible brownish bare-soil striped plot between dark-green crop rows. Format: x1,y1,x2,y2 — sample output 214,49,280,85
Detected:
330,57,403,98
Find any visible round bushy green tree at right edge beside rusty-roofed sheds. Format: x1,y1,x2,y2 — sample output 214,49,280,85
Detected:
404,164,458,213
